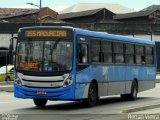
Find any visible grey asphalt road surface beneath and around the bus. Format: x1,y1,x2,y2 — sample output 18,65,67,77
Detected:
0,83,160,120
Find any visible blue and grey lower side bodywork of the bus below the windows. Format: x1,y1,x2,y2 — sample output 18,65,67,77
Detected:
75,65,156,99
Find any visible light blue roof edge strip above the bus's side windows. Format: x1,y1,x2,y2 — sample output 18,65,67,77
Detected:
75,28,155,45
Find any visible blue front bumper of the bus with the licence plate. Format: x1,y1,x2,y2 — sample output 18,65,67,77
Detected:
14,83,74,100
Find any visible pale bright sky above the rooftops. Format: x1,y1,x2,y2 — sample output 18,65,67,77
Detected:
0,0,160,12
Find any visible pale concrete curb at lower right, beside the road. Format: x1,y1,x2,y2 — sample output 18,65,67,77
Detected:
122,103,160,113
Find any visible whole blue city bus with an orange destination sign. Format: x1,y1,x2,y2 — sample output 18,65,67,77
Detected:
14,26,156,107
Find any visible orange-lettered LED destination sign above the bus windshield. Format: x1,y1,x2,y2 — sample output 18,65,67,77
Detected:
25,30,67,37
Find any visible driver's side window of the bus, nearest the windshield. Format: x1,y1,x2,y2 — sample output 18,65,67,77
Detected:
77,44,88,63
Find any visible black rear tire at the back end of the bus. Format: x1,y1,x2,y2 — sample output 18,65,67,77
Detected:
121,81,138,100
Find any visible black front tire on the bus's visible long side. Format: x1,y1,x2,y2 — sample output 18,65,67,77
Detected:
82,83,99,107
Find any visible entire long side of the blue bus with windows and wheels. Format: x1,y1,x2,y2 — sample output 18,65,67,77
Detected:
75,30,156,106
